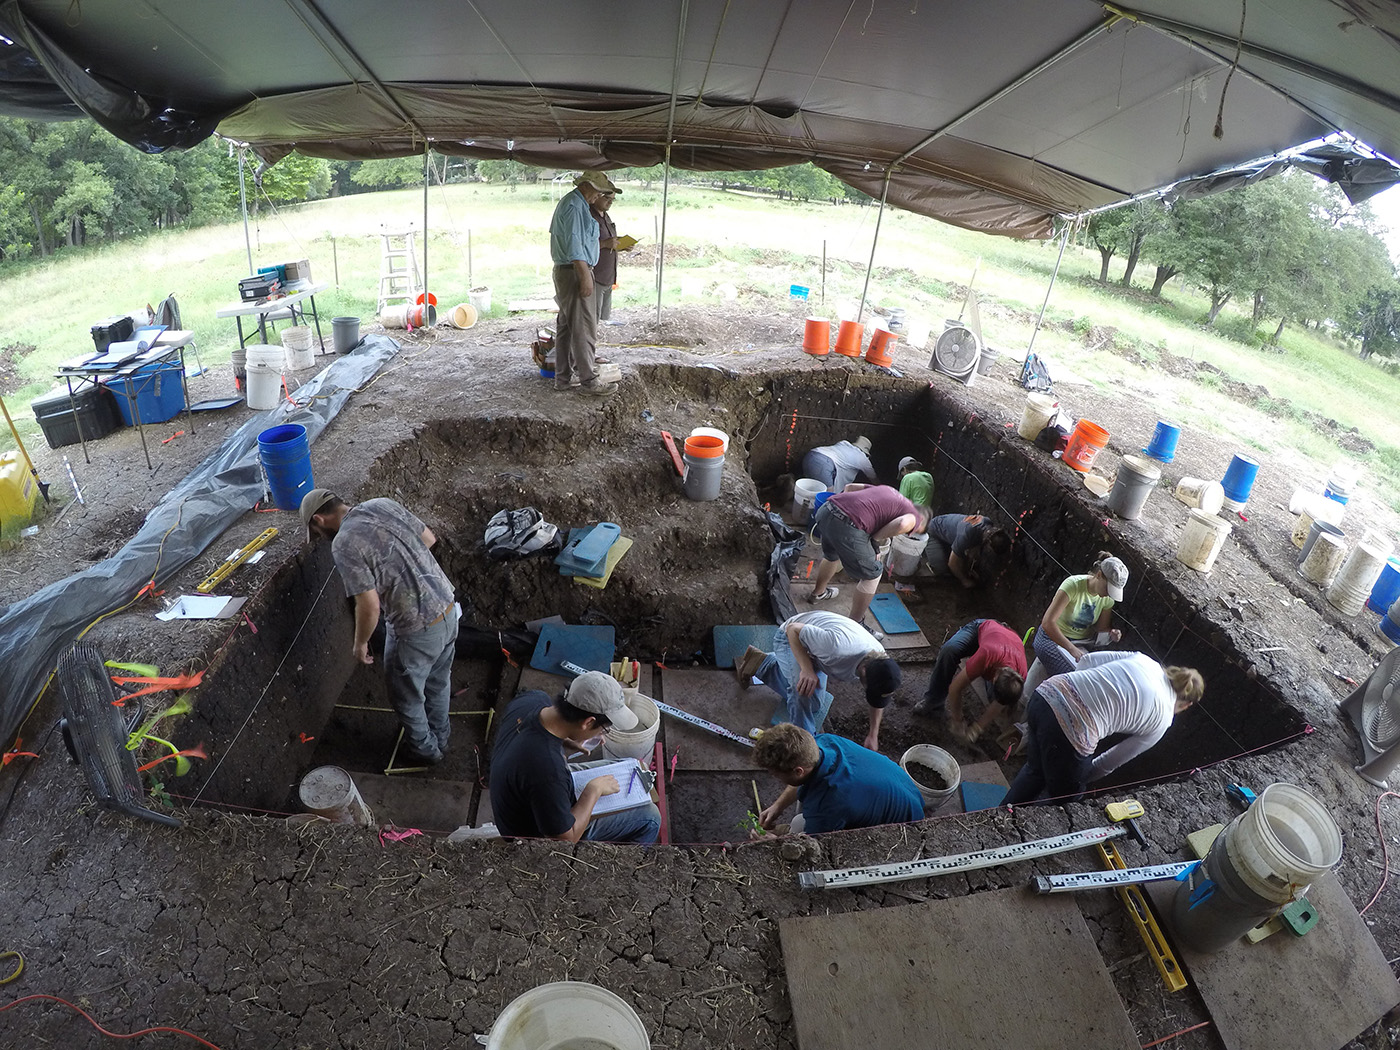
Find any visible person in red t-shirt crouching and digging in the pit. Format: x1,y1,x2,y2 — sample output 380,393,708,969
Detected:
914,620,1026,745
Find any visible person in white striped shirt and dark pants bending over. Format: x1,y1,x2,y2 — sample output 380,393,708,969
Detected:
1004,652,1205,805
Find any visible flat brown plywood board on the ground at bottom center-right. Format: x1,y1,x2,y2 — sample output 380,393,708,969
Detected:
778,889,1138,1050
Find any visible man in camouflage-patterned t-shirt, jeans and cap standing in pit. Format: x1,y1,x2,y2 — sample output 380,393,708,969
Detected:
301,489,461,766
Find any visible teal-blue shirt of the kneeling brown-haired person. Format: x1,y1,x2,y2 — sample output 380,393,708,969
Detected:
806,732,924,834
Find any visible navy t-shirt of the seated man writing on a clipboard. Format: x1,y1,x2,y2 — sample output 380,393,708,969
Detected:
491,689,578,839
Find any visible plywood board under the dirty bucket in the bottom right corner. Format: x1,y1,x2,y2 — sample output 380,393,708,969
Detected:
1145,872,1400,1050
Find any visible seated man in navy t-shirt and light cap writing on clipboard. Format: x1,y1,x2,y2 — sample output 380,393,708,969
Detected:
491,671,661,843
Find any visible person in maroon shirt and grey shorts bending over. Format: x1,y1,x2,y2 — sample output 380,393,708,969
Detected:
812,484,928,623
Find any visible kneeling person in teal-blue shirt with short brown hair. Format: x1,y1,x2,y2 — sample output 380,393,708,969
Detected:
753,724,924,834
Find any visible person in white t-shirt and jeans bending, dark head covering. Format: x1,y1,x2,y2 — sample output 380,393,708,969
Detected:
734,610,902,750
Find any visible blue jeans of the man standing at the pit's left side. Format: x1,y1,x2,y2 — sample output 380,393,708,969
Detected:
384,605,458,759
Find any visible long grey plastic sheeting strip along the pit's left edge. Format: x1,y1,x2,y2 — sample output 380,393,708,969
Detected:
0,336,399,741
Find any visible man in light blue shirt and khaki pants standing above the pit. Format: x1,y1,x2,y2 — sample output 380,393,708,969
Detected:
549,171,622,398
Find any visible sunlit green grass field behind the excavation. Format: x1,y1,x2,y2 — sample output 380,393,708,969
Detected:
0,183,1400,510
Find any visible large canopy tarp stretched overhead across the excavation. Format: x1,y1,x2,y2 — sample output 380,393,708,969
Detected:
0,0,1400,237
